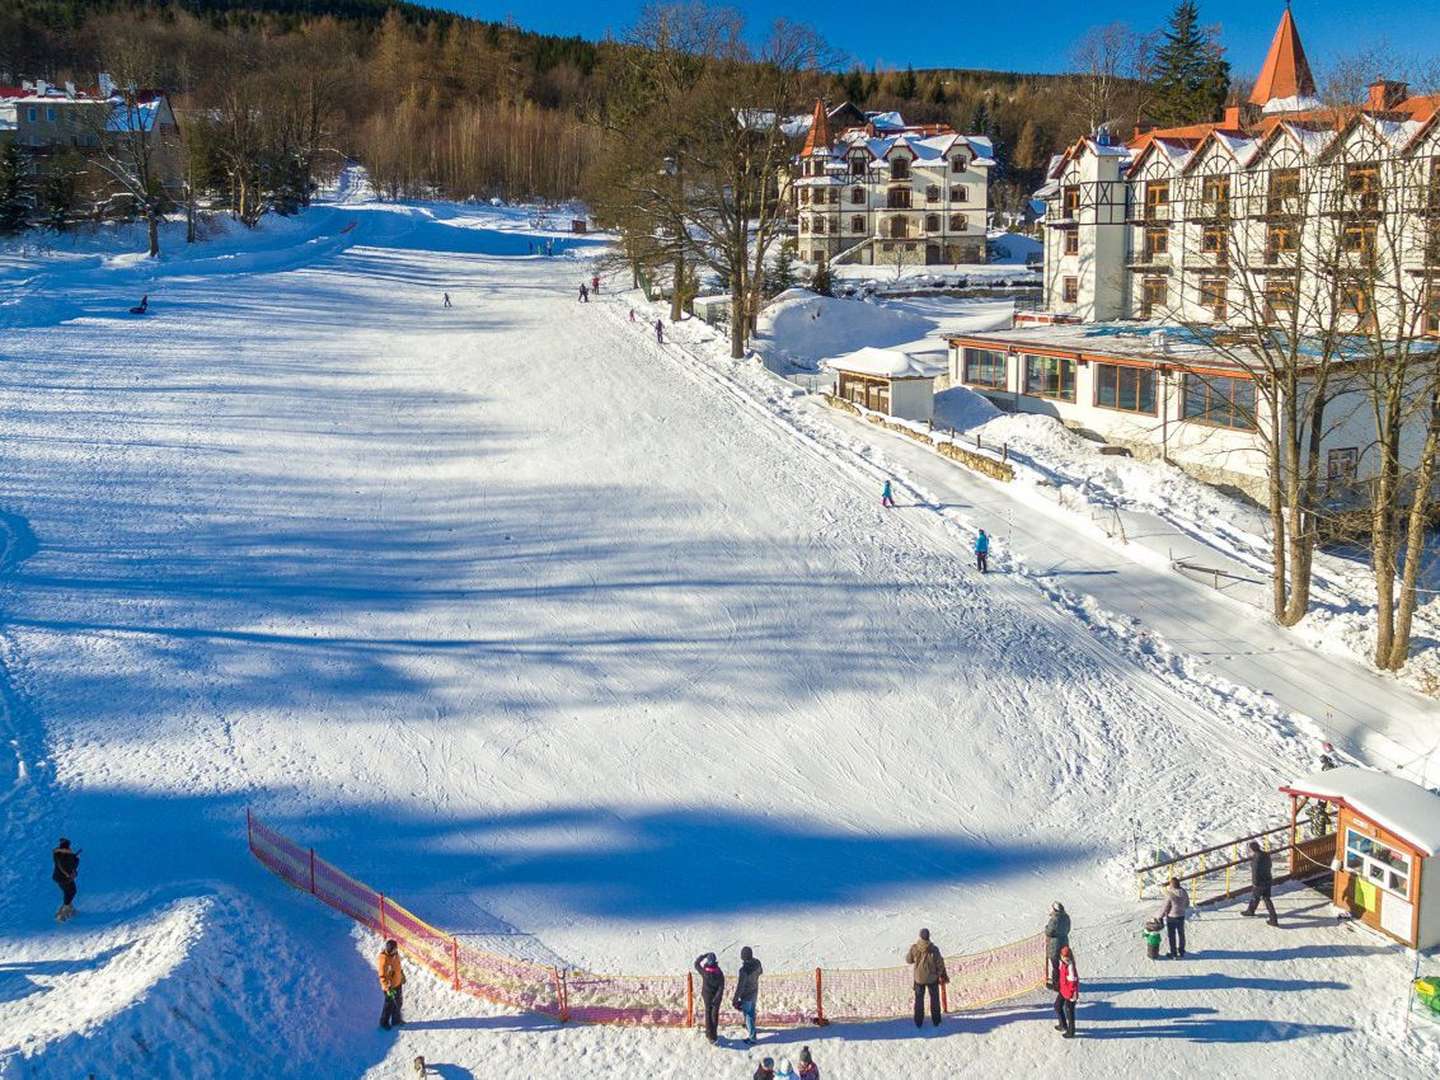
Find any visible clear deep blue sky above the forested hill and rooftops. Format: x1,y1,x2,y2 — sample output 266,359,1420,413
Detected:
443,0,1440,75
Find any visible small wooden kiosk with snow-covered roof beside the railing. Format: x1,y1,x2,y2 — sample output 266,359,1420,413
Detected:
1280,766,1440,949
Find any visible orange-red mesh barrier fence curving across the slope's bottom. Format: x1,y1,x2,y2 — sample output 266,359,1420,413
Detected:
245,811,1045,1027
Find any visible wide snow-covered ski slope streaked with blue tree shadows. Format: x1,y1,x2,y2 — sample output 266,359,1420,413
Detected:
0,203,1440,1077
